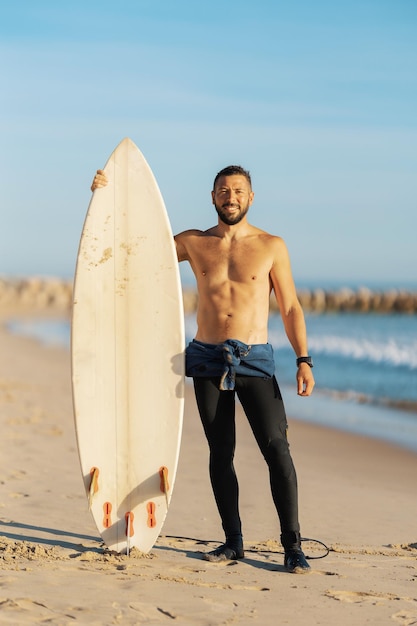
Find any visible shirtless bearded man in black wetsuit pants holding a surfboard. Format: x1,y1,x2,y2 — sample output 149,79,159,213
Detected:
91,165,314,573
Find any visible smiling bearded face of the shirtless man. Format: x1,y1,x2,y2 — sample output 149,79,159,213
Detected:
211,174,254,226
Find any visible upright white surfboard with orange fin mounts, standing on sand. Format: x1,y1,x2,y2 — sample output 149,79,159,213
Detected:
71,138,185,553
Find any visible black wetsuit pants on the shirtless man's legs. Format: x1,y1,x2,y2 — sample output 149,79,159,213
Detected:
193,375,300,548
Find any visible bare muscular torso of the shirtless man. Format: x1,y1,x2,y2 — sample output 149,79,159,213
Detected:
176,225,278,344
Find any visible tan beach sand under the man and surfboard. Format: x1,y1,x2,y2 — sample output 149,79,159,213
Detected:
0,329,417,626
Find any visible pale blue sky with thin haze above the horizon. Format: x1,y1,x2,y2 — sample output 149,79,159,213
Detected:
0,0,417,286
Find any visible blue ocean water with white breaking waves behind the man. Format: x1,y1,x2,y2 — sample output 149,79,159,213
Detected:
9,313,417,452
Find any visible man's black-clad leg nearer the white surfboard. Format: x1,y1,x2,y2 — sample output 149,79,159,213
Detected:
194,378,243,558
